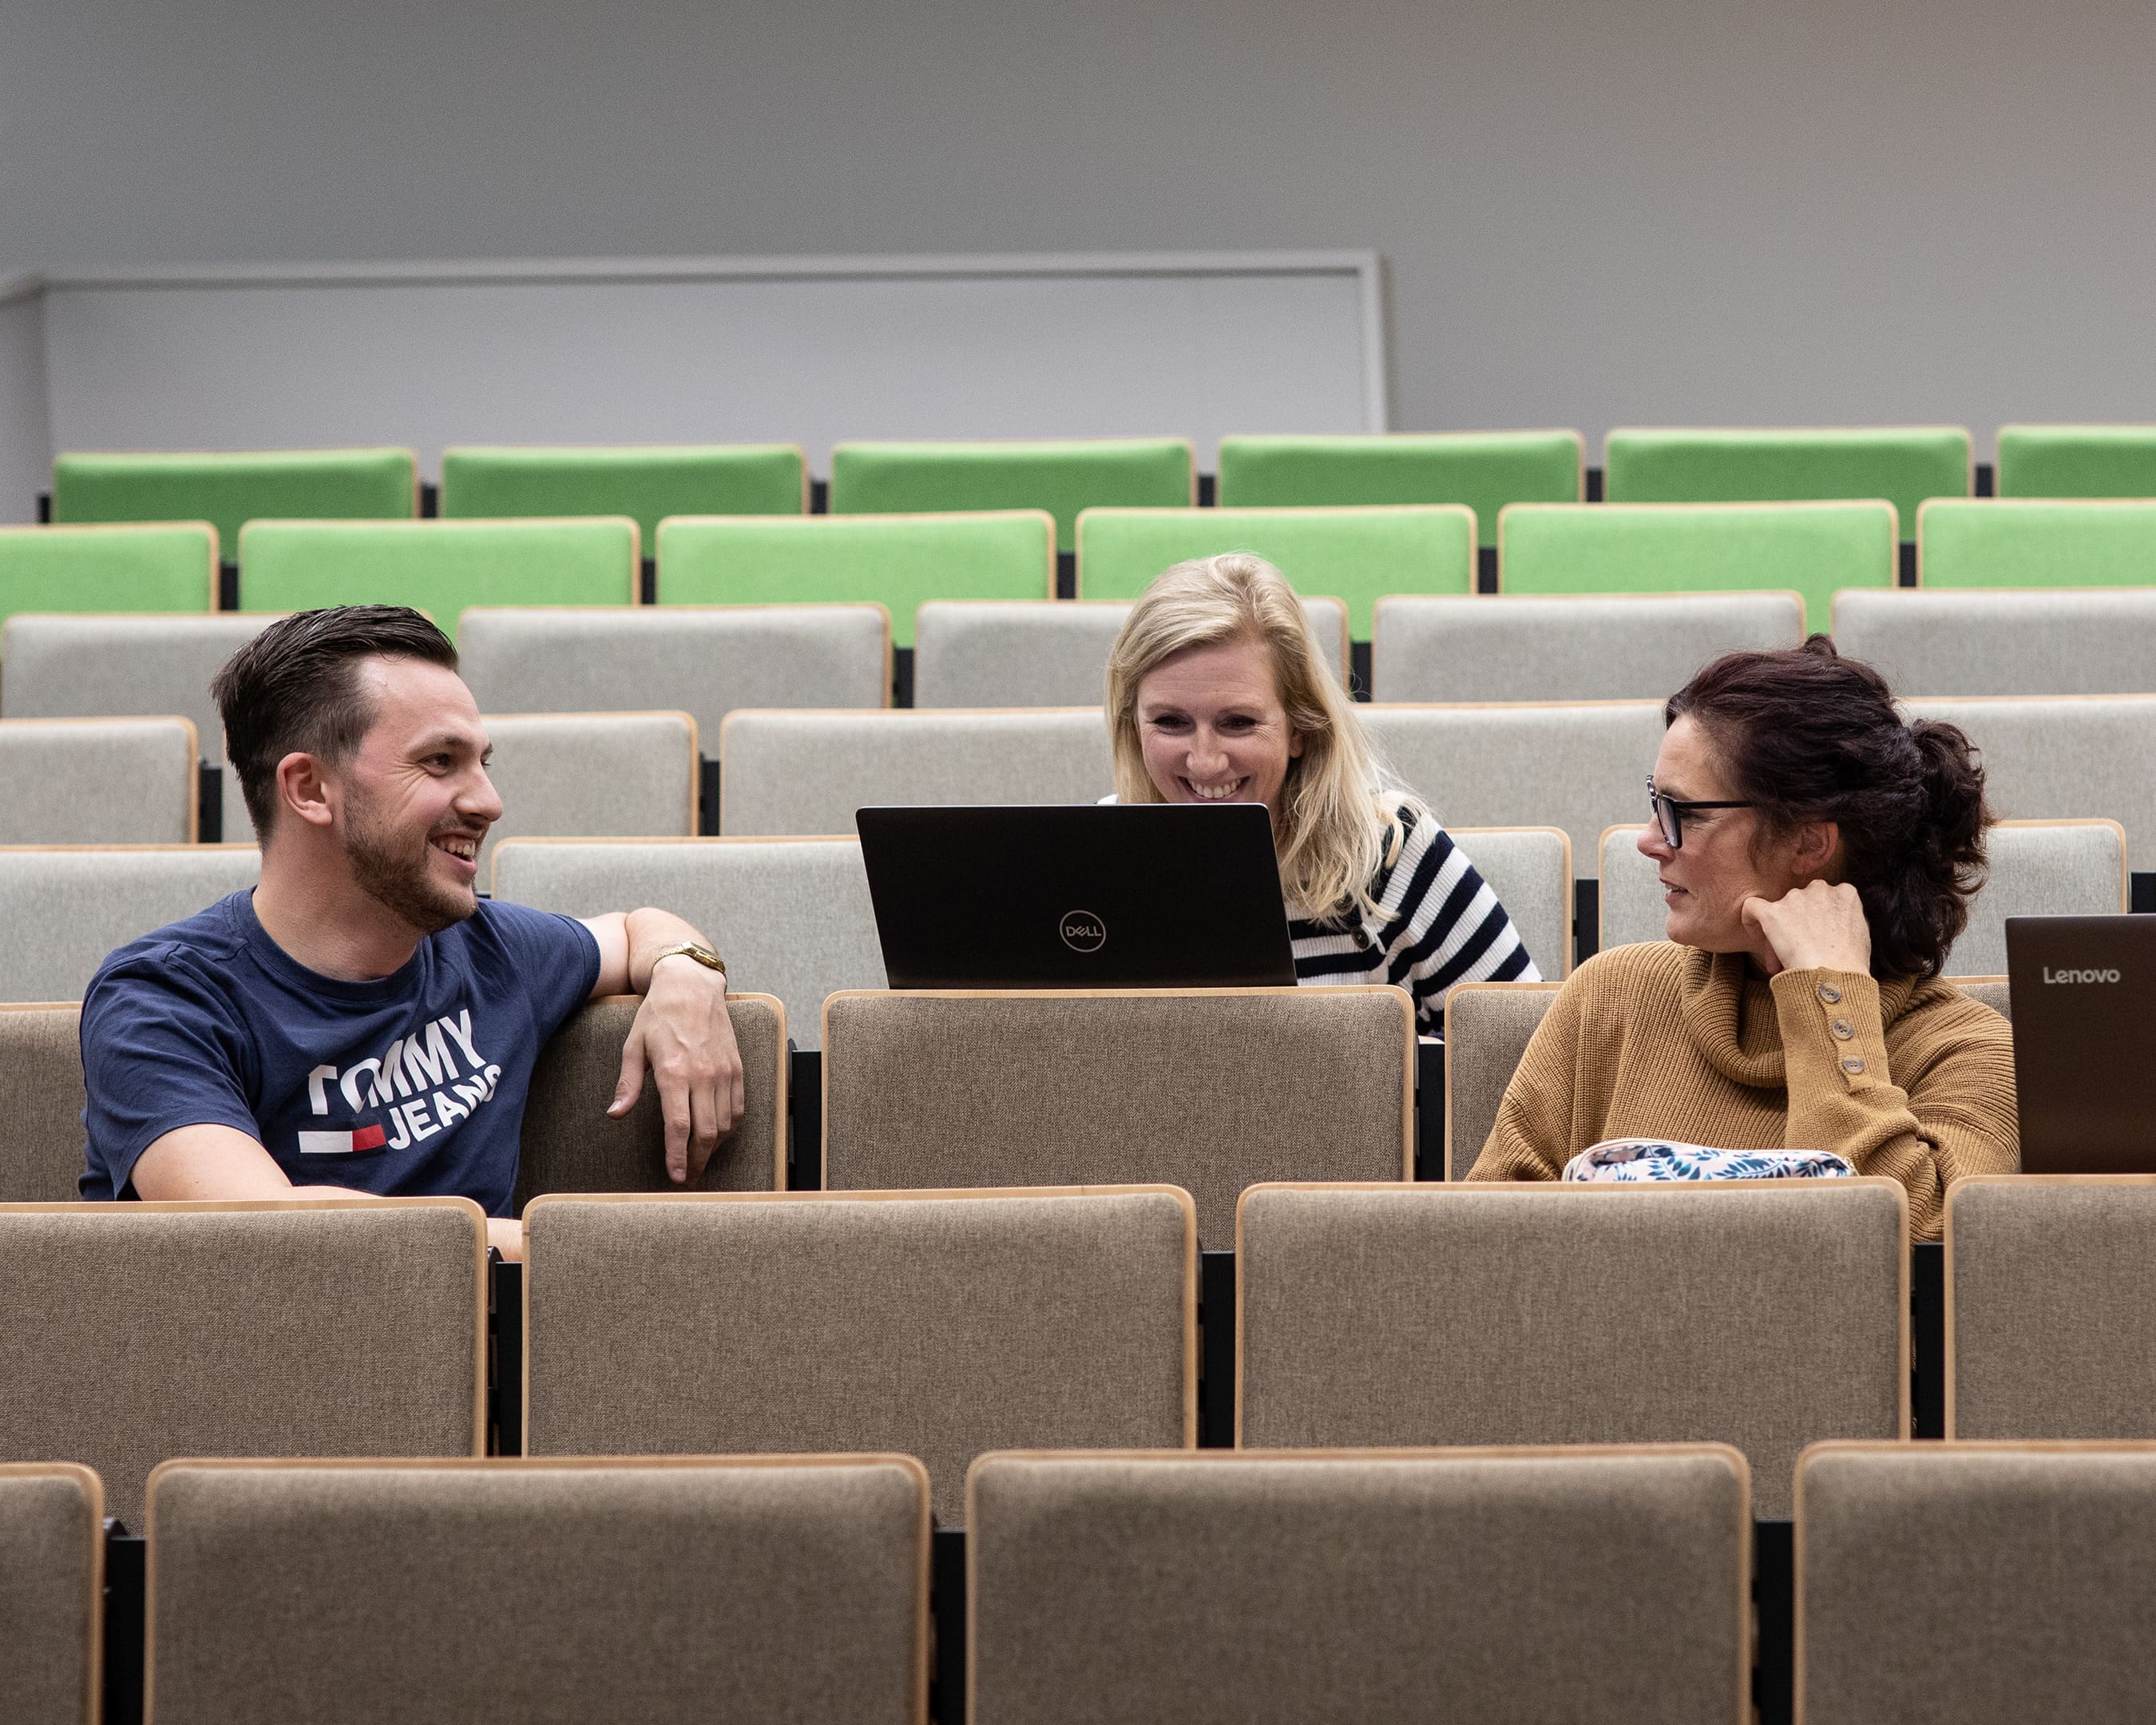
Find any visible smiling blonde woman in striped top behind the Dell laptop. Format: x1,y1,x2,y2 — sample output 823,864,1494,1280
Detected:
1108,552,1540,1035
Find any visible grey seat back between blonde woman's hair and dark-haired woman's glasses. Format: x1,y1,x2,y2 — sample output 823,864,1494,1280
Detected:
1358,701,1663,878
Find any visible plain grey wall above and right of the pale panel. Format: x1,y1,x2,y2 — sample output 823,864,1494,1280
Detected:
0,0,2156,449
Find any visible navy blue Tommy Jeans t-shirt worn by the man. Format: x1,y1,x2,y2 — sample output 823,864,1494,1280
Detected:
80,893,600,1216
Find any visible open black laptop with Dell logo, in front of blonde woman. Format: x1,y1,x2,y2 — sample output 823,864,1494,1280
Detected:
854,802,1296,988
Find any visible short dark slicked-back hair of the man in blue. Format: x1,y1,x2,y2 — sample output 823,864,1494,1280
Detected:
209,606,457,841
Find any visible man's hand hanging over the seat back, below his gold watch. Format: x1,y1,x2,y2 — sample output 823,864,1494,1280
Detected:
606,944,746,1186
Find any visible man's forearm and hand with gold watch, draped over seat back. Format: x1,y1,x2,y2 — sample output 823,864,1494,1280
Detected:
577,910,748,1190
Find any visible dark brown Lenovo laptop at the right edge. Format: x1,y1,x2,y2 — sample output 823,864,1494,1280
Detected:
2007,917,2156,1173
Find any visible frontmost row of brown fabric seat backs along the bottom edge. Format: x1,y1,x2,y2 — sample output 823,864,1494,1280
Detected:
17,1442,2156,1725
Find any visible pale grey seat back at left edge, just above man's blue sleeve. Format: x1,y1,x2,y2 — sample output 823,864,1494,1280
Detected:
0,845,261,1001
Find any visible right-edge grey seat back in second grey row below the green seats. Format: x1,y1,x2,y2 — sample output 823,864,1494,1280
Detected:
1901,694,2156,869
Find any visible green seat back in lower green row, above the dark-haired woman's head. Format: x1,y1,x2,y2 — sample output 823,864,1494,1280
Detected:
1499,502,1897,629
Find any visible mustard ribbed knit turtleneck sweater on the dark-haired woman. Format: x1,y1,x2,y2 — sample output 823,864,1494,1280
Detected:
1468,940,2020,1240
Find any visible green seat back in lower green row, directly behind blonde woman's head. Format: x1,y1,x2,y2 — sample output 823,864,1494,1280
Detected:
1078,505,1475,640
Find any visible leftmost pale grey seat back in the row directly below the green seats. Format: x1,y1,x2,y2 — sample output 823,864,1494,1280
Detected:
0,610,276,759
